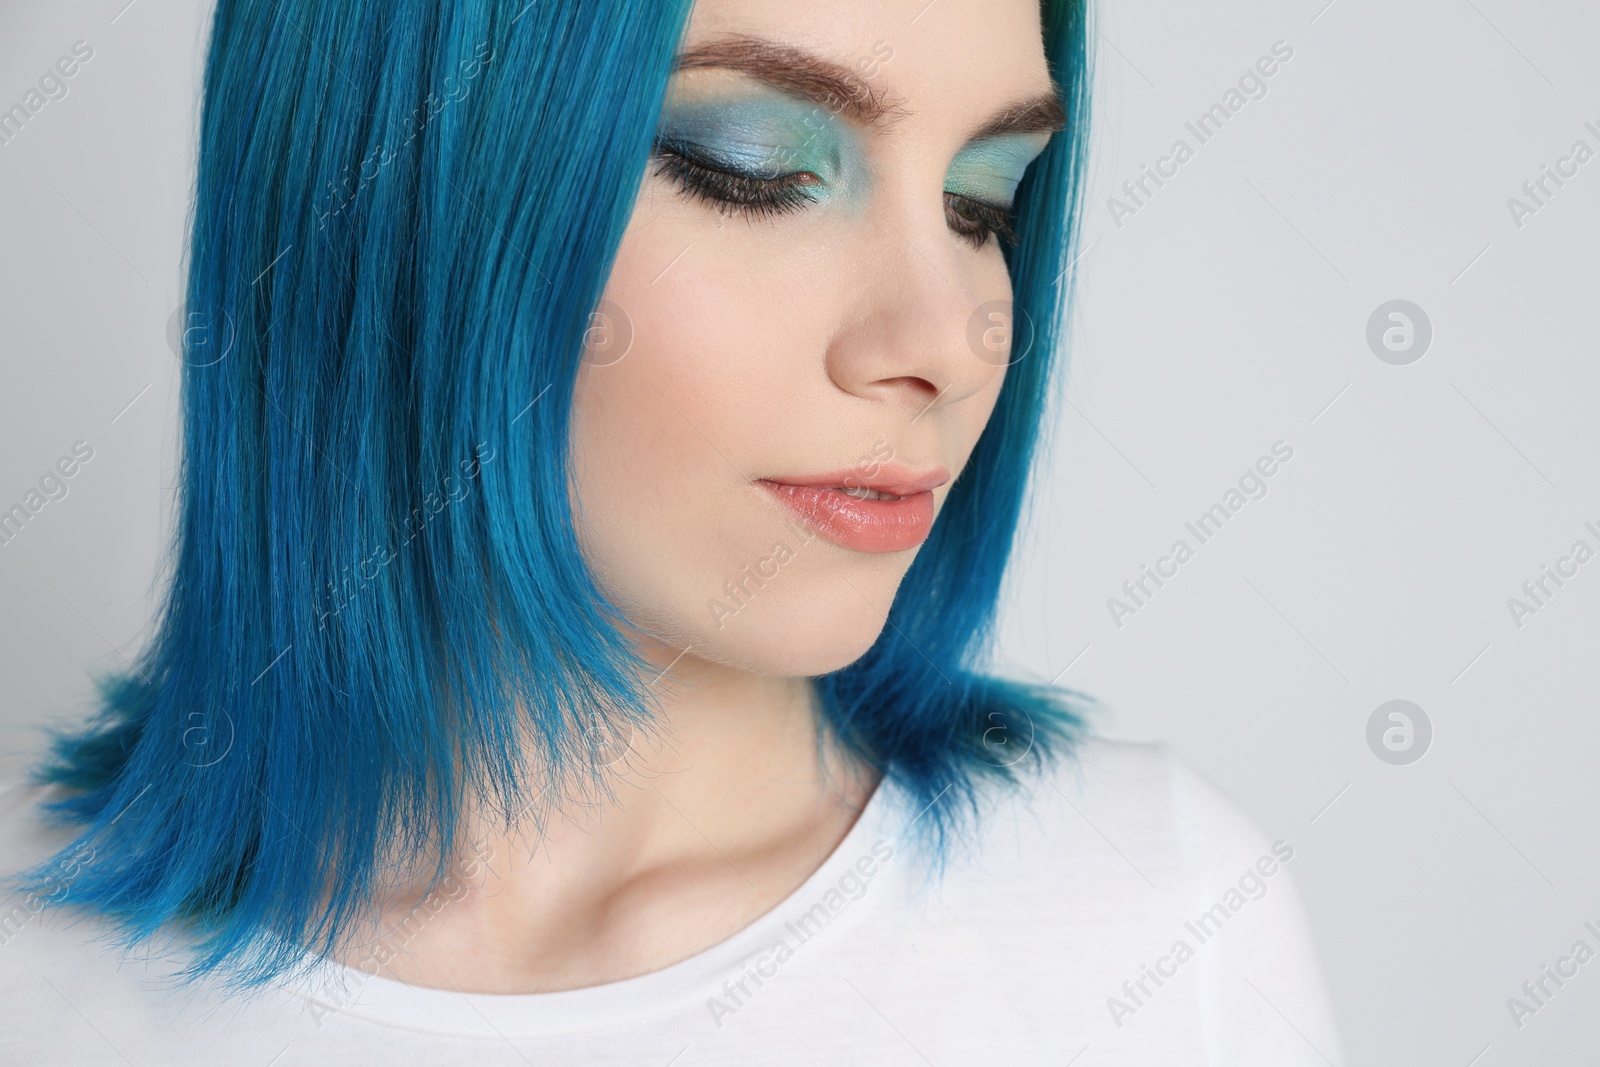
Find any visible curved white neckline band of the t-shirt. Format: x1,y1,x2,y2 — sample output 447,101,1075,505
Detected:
286,779,901,1037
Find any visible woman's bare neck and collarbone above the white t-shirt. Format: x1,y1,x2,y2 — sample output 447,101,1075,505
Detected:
342,649,877,993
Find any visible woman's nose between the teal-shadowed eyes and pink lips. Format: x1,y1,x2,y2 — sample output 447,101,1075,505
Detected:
827,213,1011,414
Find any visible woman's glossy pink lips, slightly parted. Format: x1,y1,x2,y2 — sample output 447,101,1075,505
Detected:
760,464,950,552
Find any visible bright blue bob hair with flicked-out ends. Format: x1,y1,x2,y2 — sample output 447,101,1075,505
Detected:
11,0,1090,992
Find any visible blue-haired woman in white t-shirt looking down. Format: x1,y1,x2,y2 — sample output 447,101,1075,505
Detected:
0,0,1339,1065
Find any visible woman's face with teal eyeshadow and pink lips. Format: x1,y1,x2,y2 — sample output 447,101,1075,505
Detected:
573,0,1061,675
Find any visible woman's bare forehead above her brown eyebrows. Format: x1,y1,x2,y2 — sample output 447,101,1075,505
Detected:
683,0,1051,141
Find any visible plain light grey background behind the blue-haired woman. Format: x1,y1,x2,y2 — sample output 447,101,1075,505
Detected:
0,0,1600,1067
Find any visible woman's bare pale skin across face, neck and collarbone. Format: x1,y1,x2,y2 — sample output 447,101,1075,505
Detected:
344,0,1053,993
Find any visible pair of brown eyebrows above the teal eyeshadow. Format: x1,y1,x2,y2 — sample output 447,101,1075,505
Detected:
674,35,1067,141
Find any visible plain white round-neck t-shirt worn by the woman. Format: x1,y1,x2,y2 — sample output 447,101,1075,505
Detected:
0,739,1342,1067
